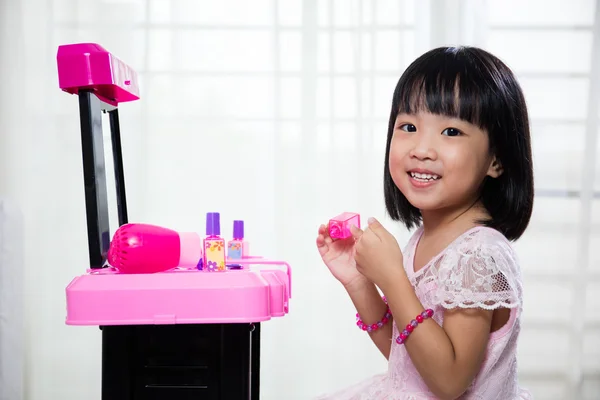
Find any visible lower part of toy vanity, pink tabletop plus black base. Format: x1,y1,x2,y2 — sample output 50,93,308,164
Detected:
66,259,291,400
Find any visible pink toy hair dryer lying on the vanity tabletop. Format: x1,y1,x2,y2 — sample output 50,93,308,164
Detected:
108,224,202,274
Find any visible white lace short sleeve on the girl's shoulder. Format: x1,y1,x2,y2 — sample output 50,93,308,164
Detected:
432,229,521,310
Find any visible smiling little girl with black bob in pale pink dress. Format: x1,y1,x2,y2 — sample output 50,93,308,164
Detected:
317,47,533,400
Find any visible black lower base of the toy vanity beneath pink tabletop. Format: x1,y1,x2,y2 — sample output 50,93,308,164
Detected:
101,324,260,400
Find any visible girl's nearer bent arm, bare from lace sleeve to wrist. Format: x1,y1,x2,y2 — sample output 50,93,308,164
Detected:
382,276,493,400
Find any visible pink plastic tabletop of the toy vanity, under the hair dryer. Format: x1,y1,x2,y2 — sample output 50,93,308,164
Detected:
66,260,291,325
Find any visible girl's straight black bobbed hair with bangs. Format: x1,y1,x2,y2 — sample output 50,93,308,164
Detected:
383,47,534,240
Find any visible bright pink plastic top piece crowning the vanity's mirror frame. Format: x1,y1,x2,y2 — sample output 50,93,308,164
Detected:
56,43,140,106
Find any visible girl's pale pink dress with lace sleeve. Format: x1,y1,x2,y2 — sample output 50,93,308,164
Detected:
318,227,532,400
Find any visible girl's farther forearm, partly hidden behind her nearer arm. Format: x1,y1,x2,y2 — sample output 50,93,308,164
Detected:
346,279,393,359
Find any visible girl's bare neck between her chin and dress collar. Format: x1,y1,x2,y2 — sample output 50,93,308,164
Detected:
421,202,489,236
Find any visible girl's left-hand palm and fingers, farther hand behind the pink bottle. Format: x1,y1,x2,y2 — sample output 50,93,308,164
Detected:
317,225,368,290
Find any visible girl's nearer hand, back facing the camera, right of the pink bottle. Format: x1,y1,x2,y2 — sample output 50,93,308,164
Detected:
351,218,406,293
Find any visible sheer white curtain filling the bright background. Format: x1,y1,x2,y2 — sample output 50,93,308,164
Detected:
0,0,600,400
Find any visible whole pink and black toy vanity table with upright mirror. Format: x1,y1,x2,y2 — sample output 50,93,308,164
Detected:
57,43,291,400
